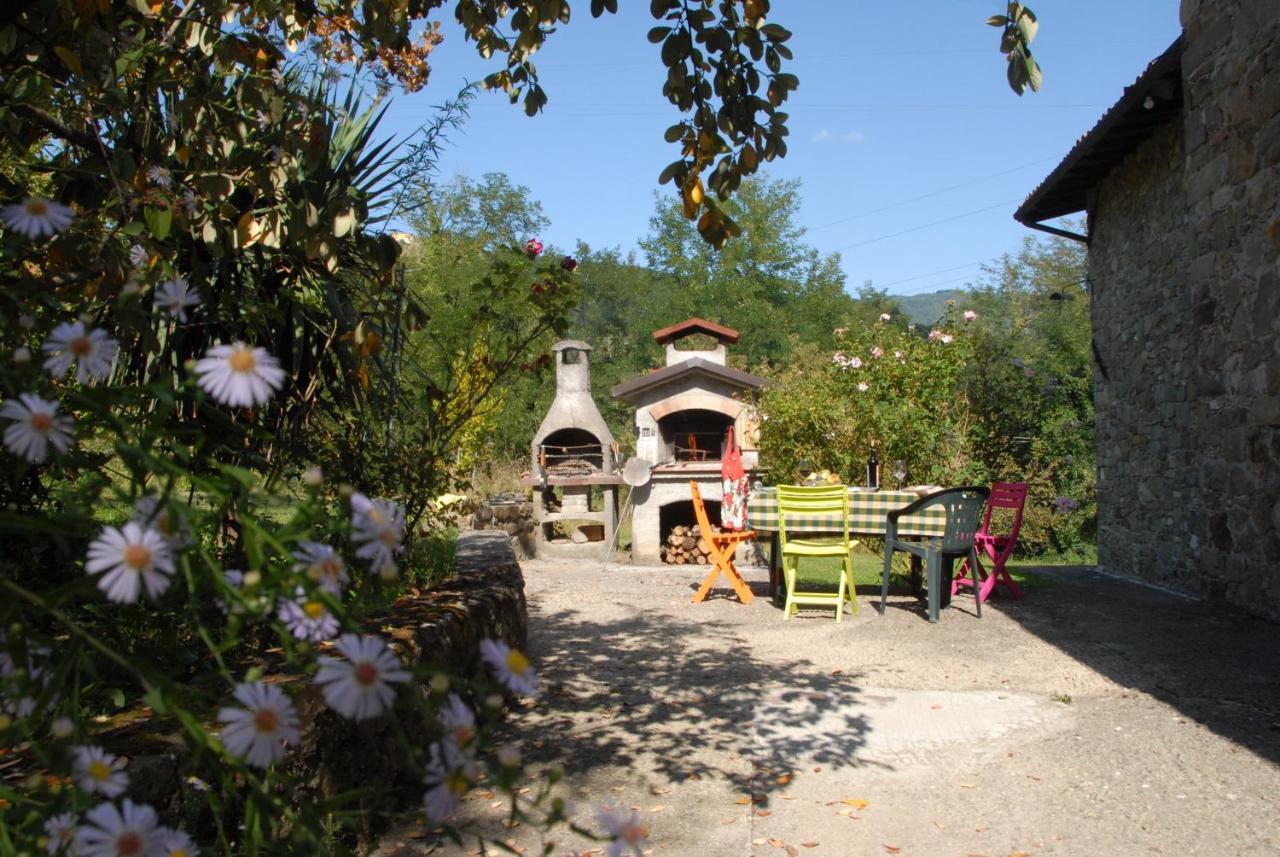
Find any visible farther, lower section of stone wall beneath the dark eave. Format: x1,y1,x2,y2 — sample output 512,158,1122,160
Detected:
1089,120,1202,598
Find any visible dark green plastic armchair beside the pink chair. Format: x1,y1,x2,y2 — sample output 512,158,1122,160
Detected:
881,485,991,622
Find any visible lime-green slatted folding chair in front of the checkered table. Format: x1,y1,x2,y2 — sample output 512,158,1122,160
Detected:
778,485,858,622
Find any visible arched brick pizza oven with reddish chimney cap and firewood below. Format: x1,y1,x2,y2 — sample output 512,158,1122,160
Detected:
611,318,764,563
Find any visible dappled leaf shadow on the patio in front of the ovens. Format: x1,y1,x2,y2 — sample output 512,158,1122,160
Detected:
521,610,885,805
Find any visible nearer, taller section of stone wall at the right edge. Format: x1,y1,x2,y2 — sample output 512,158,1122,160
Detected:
1183,0,1280,618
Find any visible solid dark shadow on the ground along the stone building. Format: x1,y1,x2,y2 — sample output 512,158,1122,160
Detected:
984,567,1280,764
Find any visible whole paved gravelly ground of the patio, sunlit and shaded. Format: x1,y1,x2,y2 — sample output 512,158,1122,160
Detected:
379,560,1280,857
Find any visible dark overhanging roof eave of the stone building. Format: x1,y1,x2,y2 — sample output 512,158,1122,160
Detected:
1014,37,1183,230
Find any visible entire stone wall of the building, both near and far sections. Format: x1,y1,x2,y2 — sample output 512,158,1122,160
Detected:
1089,0,1280,618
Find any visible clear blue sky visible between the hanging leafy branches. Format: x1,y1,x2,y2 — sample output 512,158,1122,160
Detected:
384,0,1179,294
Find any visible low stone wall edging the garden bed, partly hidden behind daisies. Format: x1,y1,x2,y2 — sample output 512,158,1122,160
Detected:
117,531,529,843
